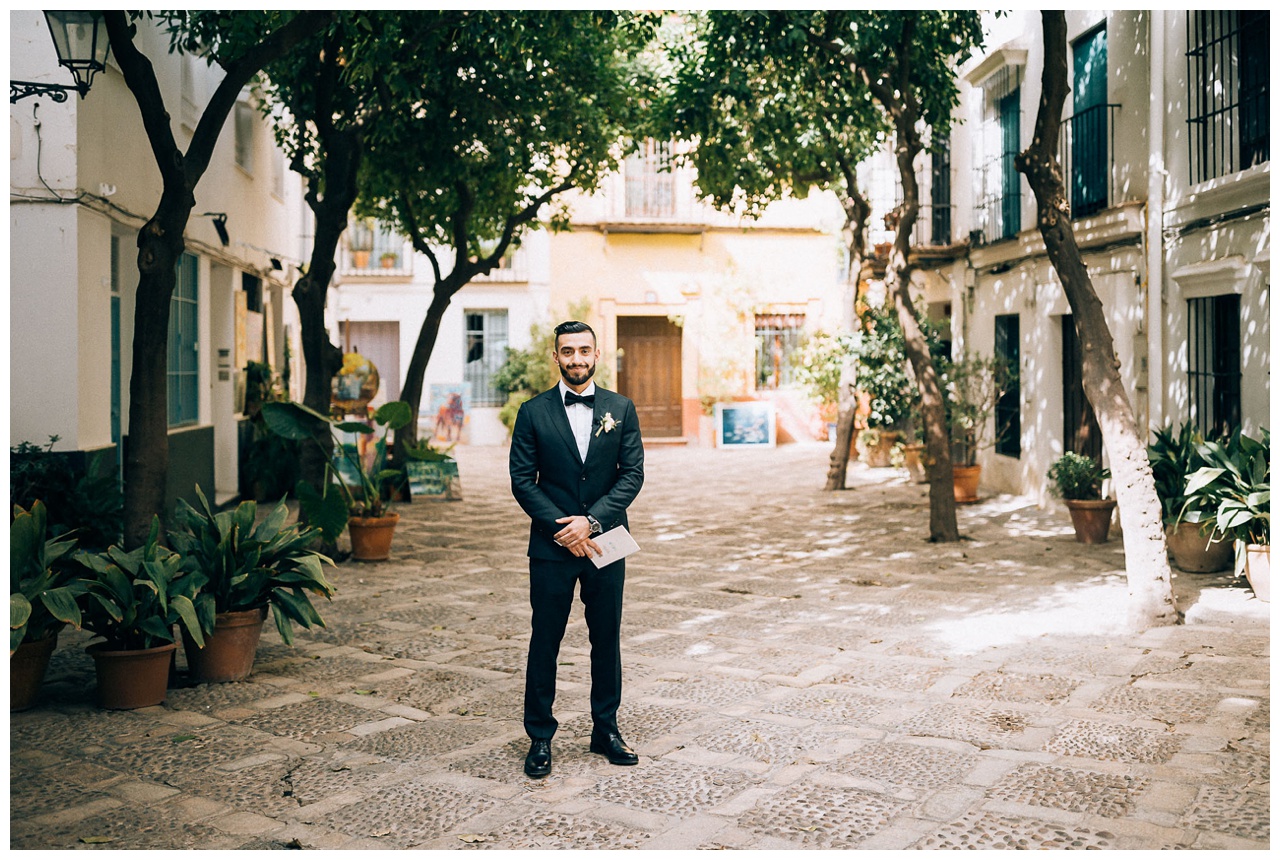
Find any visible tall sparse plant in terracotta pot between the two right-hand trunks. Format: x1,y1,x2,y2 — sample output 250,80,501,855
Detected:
942,352,1012,503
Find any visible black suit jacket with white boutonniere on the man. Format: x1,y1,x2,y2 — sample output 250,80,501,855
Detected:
511,385,644,561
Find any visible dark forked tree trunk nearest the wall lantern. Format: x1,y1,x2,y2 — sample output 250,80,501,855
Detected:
104,12,332,549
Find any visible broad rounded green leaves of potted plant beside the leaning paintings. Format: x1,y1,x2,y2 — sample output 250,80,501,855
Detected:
262,401,413,541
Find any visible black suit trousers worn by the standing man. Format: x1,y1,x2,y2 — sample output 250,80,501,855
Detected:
525,558,626,740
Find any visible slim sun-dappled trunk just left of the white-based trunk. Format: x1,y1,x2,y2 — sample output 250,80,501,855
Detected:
884,126,960,543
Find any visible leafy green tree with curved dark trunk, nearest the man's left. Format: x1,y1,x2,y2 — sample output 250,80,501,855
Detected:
349,10,655,447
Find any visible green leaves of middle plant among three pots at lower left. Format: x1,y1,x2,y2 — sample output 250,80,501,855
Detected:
76,517,212,650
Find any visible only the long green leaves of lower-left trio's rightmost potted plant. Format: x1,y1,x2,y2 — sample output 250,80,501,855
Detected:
169,486,334,645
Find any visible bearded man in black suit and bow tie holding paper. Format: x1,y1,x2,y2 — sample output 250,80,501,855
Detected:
511,321,644,778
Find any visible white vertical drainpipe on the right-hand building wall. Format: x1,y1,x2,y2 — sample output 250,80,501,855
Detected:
1146,9,1167,429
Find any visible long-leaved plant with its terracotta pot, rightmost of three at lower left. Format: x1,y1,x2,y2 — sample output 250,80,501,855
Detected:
169,486,333,682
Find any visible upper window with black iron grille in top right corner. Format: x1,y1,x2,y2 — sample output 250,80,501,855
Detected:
1187,9,1271,183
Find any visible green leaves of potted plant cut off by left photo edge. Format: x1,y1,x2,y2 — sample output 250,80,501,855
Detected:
9,500,84,655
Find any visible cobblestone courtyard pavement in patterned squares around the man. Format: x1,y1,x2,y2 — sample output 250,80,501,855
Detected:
9,445,1271,850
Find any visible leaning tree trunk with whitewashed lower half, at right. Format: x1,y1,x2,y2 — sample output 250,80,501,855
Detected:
1016,12,1178,628
